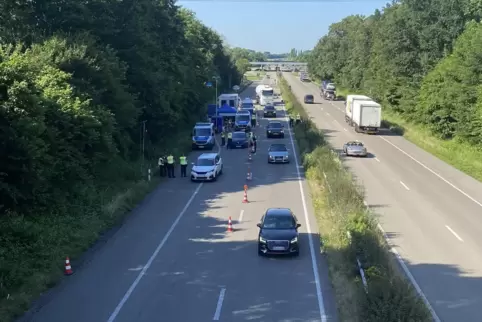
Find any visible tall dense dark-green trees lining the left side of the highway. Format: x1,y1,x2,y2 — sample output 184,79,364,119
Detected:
0,0,242,212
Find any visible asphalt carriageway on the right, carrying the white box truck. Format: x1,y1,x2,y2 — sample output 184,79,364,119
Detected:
284,73,482,322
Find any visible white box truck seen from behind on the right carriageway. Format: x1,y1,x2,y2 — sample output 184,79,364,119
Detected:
352,100,382,134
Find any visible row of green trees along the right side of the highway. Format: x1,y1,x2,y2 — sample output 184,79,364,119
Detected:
308,0,482,145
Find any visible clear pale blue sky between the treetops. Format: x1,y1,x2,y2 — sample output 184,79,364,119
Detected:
178,0,390,53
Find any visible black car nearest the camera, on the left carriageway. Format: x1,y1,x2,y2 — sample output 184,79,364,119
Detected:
257,208,301,256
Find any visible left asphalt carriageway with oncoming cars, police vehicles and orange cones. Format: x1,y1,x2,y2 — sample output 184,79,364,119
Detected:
21,79,336,322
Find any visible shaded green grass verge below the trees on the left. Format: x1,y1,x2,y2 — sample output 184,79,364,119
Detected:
0,132,191,322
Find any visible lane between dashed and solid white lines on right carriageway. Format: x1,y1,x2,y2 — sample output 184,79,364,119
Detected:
294,75,482,249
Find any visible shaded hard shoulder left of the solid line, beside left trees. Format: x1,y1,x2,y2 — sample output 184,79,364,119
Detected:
19,85,254,322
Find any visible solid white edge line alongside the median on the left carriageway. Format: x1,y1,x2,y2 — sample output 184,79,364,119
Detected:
283,107,327,322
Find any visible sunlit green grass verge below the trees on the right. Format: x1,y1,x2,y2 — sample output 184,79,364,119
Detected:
338,89,482,181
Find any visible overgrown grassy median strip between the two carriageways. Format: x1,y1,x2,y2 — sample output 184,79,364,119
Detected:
279,78,431,322
